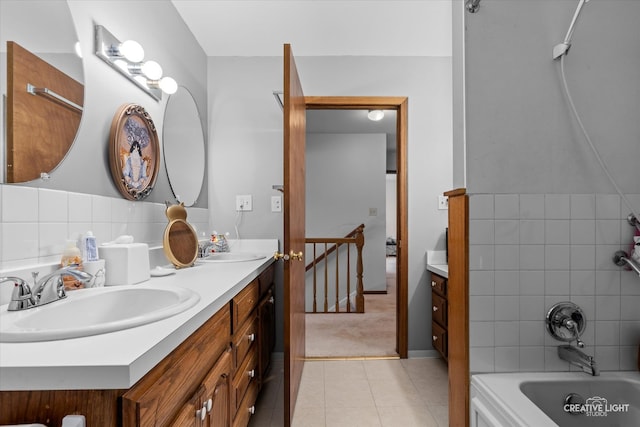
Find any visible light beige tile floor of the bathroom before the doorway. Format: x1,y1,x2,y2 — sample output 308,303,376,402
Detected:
249,358,448,427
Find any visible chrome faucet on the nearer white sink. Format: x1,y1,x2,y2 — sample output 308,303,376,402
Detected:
0,266,93,311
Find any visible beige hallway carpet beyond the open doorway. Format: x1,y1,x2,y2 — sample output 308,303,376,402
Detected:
306,257,398,358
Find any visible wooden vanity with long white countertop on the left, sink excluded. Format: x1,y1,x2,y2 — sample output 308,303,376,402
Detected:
0,240,277,427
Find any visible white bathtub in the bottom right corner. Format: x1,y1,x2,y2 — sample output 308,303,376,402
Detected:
470,371,640,427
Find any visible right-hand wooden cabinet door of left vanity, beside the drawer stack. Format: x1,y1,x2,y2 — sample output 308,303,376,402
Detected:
202,351,231,427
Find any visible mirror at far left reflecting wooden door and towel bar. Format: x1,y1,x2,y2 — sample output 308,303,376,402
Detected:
0,0,84,183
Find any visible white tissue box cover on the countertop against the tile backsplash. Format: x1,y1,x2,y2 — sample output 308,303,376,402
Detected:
100,243,151,286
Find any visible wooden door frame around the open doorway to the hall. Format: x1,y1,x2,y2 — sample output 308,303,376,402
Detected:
305,96,409,359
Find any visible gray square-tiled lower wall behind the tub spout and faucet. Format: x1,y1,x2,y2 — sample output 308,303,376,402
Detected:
469,194,640,373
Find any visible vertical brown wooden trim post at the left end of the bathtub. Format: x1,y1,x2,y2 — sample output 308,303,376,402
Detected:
444,188,469,426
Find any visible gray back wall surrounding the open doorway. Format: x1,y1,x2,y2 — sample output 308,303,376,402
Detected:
208,54,452,355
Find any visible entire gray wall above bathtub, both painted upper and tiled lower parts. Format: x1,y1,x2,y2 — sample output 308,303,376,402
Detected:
454,0,640,372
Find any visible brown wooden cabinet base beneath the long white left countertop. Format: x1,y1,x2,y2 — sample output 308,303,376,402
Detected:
0,264,275,427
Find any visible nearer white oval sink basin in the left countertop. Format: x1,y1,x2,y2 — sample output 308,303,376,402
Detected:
0,285,200,342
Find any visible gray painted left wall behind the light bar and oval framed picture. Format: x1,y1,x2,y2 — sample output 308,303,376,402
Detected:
1,0,208,207
